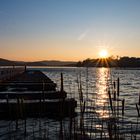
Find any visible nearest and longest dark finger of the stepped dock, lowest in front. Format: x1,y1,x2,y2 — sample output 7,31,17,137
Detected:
0,99,77,120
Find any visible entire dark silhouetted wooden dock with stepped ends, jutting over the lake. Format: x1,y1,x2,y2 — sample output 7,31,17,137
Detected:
0,69,77,119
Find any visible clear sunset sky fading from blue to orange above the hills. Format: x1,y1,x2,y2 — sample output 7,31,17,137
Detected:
0,0,140,61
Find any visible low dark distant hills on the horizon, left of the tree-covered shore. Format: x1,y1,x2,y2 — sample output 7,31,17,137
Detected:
0,58,77,66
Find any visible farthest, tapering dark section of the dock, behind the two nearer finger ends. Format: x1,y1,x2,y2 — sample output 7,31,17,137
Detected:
0,70,56,91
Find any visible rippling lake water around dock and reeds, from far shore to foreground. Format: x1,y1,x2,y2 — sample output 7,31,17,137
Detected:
0,67,140,140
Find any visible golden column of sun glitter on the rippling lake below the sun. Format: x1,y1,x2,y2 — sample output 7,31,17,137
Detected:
96,68,110,118
